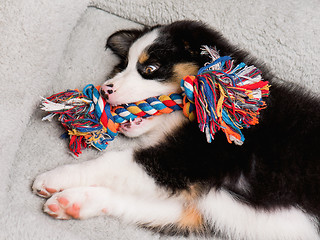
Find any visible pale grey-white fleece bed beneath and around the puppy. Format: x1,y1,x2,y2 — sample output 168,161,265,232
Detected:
0,0,320,240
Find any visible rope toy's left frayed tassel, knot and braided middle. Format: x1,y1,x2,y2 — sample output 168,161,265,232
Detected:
41,84,183,156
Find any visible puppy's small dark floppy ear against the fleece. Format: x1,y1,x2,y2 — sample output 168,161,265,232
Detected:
106,30,143,58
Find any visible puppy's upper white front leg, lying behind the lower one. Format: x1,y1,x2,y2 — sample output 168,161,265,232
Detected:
32,150,156,197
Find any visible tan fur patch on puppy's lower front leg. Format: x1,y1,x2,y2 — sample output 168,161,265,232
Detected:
178,205,203,231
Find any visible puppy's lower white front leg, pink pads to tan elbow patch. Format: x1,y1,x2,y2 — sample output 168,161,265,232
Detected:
44,187,203,231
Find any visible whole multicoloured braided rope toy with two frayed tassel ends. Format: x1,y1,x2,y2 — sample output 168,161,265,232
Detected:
41,46,270,156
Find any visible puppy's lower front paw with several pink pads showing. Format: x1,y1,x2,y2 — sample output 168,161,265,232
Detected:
43,187,107,220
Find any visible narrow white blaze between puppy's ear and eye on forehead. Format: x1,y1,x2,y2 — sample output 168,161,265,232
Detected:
128,29,159,69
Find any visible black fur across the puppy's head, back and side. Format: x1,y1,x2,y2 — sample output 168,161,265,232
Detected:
108,21,320,223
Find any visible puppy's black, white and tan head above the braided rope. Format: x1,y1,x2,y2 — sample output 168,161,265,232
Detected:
101,21,225,138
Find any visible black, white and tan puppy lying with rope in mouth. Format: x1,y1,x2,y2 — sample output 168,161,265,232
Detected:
33,21,320,240
